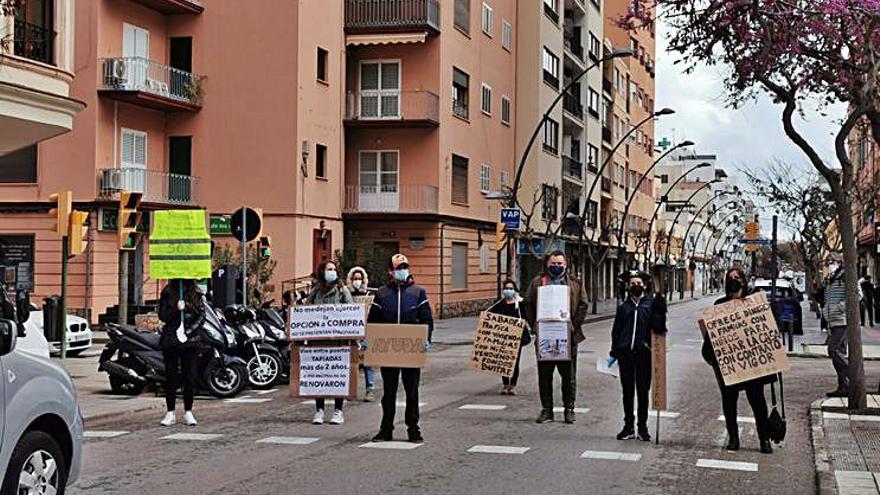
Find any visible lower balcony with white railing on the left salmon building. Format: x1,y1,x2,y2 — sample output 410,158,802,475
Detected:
98,168,199,206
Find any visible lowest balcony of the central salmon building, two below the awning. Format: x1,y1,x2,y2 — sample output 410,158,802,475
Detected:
342,184,439,215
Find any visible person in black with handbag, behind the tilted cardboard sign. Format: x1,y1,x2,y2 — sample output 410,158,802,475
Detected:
702,267,776,454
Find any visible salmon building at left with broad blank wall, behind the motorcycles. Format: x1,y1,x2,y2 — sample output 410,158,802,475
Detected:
0,0,345,320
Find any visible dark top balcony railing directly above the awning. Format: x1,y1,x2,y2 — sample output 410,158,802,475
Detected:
345,0,440,33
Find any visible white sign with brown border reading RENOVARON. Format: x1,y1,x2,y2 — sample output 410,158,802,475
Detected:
290,346,358,398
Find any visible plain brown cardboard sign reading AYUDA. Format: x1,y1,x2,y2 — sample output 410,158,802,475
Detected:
364,323,428,368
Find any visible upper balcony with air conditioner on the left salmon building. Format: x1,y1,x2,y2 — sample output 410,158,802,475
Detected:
98,57,202,112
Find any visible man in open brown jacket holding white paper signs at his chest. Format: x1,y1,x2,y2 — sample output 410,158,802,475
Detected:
525,251,587,424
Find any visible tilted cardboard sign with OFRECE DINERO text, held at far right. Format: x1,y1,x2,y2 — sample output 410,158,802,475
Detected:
699,292,788,386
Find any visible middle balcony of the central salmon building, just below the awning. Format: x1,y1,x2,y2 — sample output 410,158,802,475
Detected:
345,90,440,127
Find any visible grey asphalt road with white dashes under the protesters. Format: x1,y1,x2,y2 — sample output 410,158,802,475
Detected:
69,300,878,495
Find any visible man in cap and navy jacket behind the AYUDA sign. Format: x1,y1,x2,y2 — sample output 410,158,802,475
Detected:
368,254,434,443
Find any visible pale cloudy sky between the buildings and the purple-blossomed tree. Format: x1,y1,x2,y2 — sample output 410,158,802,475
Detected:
655,22,846,237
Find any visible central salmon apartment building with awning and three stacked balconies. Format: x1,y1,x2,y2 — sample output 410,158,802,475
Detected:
343,0,527,317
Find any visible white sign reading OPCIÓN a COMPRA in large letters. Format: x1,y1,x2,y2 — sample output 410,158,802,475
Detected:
288,304,366,340
